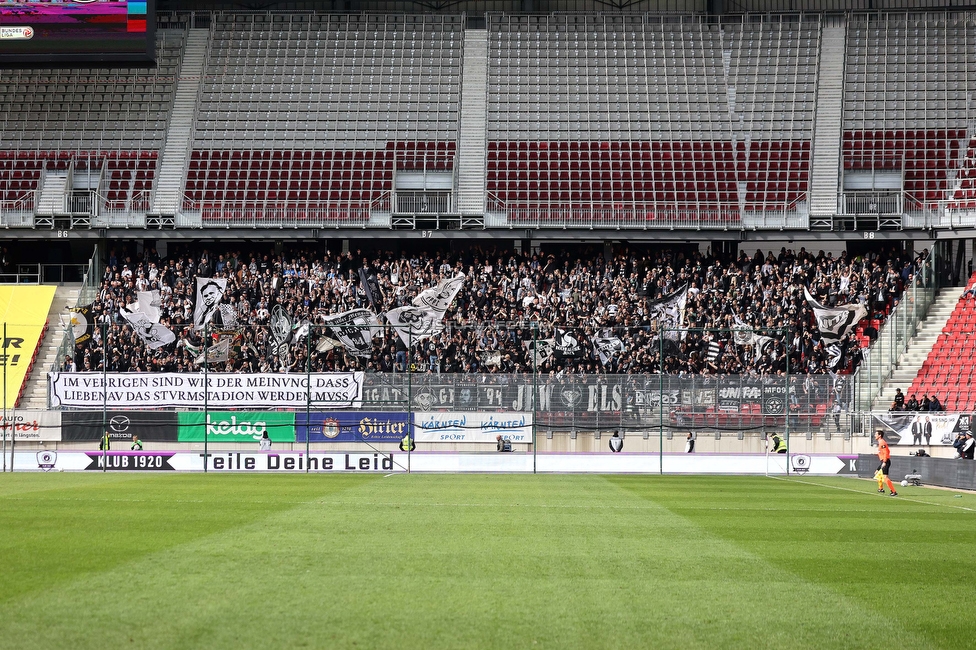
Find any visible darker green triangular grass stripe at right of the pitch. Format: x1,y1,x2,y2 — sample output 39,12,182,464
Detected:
613,470,976,648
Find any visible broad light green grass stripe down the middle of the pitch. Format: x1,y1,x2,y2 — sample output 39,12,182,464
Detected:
0,475,960,648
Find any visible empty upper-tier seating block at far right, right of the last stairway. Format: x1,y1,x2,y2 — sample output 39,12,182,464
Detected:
843,12,976,213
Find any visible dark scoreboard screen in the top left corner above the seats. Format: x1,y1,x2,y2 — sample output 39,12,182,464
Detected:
0,0,156,64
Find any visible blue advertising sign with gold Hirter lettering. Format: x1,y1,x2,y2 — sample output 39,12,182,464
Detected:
295,411,407,442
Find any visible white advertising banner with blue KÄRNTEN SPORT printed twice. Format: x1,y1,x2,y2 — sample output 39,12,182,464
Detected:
413,411,532,443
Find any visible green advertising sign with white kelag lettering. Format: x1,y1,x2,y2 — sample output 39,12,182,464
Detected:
179,411,295,443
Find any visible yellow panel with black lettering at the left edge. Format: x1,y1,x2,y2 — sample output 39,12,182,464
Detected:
0,284,55,409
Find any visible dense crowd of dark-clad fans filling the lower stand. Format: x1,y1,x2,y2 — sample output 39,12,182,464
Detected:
65,242,927,375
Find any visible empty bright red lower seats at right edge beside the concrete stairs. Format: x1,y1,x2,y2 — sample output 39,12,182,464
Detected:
907,273,976,412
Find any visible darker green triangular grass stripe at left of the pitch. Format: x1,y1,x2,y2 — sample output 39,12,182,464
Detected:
0,474,377,604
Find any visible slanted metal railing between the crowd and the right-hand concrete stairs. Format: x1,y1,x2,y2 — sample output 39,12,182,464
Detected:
854,249,937,411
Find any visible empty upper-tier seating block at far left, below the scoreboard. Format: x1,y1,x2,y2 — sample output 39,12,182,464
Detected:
0,29,185,218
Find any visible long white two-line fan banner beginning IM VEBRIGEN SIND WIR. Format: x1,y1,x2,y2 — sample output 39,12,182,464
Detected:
48,372,363,409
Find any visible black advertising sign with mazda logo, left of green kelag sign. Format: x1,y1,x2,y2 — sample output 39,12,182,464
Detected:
61,410,177,442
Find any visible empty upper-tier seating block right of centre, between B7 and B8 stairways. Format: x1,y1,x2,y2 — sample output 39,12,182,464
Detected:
486,14,820,226
